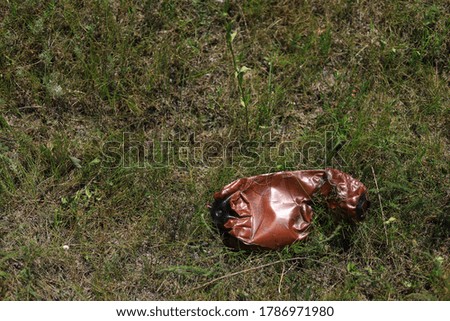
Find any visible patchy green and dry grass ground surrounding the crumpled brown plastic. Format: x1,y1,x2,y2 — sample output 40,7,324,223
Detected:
0,0,450,300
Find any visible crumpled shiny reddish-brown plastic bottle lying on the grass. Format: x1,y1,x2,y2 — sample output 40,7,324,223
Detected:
210,168,370,249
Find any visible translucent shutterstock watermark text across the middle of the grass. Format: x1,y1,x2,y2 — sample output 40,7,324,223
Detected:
102,132,347,168
